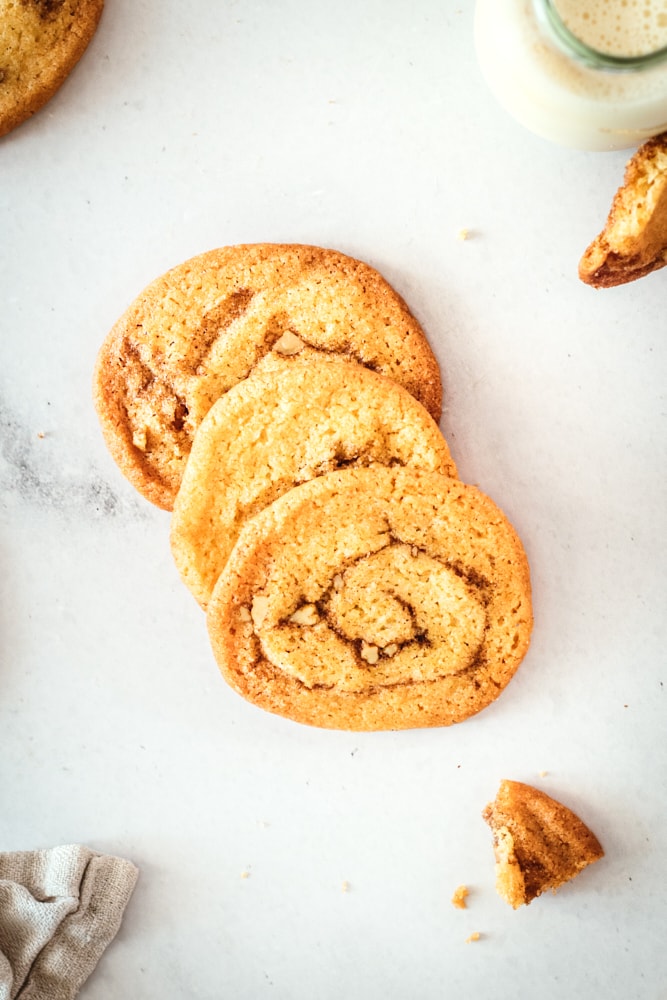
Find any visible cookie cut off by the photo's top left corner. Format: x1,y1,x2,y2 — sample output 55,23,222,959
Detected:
0,0,104,136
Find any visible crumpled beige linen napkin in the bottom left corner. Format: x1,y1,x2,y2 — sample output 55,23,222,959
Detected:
0,844,139,1000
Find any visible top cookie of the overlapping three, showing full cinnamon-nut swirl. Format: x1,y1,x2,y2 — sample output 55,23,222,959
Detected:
207,466,532,730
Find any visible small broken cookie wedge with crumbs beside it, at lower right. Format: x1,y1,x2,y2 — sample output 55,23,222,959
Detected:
482,781,604,910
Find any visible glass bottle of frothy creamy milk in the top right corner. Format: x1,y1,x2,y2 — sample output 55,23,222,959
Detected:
475,0,667,150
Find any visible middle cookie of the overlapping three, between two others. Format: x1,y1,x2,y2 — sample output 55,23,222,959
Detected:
171,349,457,607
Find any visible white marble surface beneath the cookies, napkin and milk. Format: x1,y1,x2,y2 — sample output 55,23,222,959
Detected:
0,0,667,1000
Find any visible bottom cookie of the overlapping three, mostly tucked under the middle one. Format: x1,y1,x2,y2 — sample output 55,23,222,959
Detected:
94,244,442,510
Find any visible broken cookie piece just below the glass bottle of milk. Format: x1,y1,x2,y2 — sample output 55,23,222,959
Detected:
579,132,667,288
